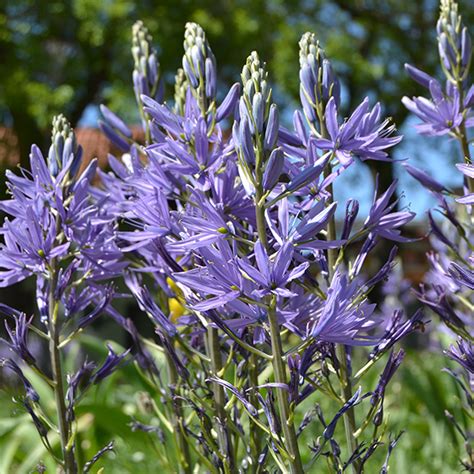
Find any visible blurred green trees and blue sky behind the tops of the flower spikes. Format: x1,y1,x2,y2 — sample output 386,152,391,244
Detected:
0,0,474,214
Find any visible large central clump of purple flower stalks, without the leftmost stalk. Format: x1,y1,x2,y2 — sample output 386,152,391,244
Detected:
92,17,422,473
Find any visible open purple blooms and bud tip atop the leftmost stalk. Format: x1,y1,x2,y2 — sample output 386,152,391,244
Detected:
0,117,125,286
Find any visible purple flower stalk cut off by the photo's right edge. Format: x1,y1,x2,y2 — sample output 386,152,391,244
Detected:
403,0,474,471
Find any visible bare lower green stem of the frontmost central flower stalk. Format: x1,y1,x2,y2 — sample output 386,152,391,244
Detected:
268,297,304,474
